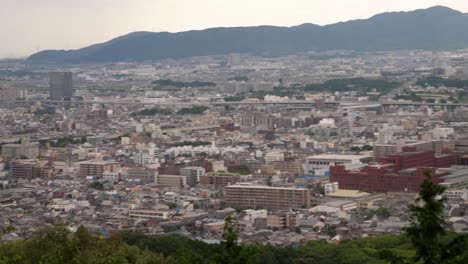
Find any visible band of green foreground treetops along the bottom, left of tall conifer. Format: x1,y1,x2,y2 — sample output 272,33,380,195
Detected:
0,226,468,264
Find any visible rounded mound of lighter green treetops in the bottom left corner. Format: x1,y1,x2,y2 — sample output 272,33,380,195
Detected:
0,223,171,264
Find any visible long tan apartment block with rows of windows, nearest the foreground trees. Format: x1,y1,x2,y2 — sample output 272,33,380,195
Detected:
225,184,310,210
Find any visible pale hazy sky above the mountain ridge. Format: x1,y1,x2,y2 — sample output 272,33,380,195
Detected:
0,0,468,57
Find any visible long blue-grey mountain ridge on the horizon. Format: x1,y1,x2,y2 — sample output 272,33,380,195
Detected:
28,6,468,63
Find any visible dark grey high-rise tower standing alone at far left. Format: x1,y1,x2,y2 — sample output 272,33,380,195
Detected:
49,72,73,101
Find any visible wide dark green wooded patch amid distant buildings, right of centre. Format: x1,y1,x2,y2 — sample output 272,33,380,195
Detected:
304,78,401,93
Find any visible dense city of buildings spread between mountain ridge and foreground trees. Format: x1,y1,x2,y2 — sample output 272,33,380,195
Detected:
0,1,468,263
